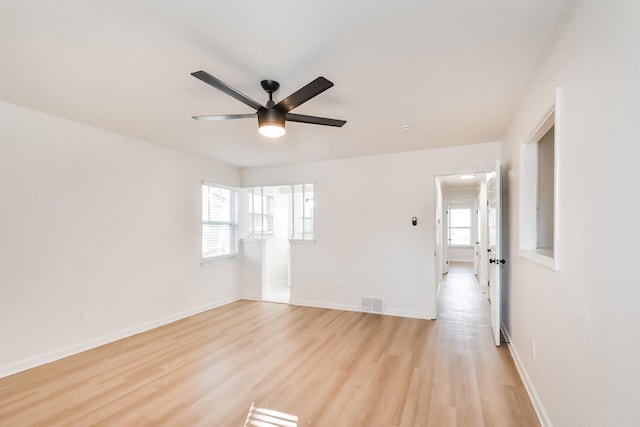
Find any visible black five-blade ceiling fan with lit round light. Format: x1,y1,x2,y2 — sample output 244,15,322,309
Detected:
191,71,347,138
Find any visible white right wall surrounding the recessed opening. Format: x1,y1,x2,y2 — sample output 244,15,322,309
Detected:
504,0,640,427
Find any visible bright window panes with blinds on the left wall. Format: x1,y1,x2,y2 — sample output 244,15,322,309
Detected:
202,184,238,262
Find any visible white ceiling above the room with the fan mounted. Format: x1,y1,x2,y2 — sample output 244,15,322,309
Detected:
0,0,572,167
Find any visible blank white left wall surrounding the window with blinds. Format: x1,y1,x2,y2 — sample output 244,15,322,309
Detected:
0,102,240,376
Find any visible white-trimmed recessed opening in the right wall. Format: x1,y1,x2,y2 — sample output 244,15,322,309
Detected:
520,96,559,270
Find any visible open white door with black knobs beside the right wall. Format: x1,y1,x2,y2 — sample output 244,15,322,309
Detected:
487,160,505,346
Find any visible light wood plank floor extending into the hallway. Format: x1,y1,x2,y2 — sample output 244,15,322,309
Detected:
0,267,539,427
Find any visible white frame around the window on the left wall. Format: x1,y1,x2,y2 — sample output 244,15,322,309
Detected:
200,181,239,265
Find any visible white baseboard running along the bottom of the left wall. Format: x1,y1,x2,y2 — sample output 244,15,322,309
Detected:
0,297,241,378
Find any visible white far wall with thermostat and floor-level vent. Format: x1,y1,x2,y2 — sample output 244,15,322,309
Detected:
241,143,501,318
